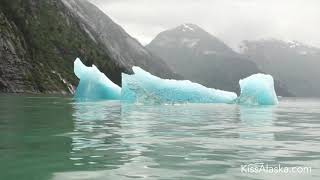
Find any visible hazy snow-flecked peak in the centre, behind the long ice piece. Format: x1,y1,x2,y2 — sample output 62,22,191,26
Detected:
146,24,290,96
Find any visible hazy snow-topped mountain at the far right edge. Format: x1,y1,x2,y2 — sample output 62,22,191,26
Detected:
241,39,320,97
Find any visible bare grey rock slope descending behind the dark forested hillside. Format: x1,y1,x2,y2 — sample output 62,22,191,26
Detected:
62,0,180,78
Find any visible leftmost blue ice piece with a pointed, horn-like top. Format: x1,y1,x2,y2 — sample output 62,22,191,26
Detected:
74,58,121,101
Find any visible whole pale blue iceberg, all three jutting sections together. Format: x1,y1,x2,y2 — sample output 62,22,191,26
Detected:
74,59,278,105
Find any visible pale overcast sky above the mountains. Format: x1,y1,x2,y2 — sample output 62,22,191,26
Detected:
91,0,320,48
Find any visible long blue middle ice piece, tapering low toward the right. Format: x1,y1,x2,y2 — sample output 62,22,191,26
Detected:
121,67,237,104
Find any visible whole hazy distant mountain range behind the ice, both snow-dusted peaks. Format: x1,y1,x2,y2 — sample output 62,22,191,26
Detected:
146,24,320,97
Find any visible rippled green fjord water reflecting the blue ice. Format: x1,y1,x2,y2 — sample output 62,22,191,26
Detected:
0,95,320,180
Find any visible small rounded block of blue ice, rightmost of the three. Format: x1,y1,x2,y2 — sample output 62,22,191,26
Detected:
237,74,278,105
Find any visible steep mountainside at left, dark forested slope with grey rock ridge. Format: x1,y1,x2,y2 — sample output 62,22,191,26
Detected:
0,0,177,94
